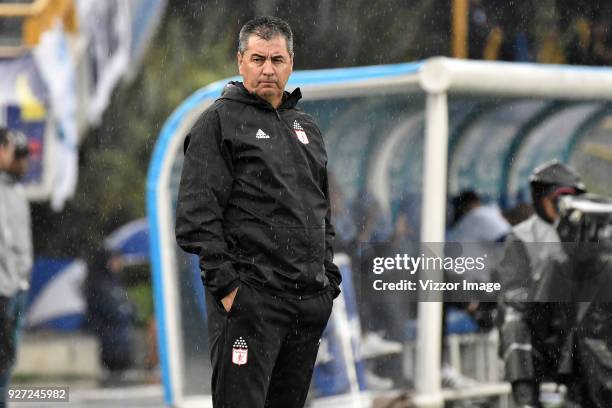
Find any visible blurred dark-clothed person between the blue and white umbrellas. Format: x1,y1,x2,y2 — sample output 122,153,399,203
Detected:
85,249,136,383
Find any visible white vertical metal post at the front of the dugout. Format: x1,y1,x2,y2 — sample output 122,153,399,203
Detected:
415,92,448,408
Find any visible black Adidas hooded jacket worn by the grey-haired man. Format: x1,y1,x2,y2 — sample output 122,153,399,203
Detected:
176,82,341,299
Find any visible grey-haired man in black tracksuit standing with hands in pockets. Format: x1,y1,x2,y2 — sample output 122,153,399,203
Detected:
176,17,341,408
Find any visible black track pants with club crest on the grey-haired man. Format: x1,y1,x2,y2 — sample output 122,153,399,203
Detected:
206,283,333,408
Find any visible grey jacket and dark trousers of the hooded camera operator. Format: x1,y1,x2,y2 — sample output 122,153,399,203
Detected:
494,214,568,403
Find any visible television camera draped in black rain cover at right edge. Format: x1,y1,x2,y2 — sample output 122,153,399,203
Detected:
536,194,612,408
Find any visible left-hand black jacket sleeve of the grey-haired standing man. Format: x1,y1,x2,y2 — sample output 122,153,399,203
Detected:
175,111,239,299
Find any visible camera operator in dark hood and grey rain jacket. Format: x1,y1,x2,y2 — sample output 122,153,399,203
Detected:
495,161,586,408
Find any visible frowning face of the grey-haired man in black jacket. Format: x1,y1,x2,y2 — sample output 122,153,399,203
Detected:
238,35,293,108
